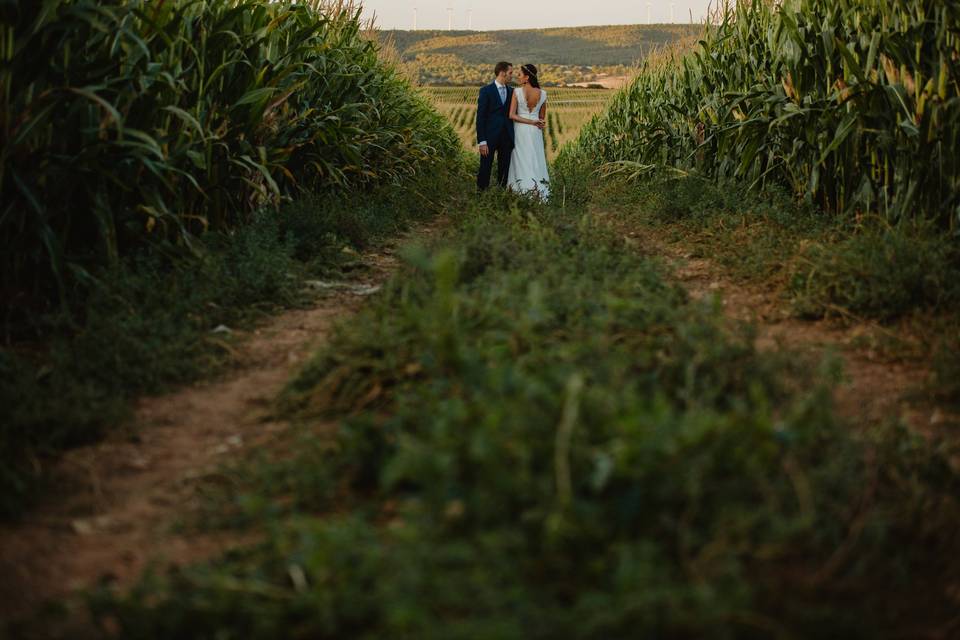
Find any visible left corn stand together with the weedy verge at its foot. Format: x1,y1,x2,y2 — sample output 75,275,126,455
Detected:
0,0,459,515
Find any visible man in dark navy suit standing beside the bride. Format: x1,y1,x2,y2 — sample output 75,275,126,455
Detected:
477,62,513,191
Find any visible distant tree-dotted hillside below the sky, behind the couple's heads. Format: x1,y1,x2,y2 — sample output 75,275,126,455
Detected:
380,24,701,86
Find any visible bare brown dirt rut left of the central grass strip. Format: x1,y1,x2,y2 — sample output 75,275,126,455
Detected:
0,224,438,632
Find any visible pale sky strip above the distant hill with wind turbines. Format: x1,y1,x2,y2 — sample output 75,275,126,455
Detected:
362,0,716,31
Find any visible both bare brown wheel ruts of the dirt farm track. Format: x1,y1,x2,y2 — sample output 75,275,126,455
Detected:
0,210,956,636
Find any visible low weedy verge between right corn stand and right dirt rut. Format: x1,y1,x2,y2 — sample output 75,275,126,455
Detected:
559,158,960,322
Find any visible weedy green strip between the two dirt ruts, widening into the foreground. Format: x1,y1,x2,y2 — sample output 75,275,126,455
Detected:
91,194,960,639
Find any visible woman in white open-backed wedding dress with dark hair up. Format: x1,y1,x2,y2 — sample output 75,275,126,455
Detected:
507,64,550,200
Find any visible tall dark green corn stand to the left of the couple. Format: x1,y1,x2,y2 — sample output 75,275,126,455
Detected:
0,0,457,312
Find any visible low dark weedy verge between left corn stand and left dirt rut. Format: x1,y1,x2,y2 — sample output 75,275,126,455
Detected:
0,170,456,516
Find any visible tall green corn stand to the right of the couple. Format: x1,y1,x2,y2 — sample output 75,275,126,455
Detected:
571,0,960,230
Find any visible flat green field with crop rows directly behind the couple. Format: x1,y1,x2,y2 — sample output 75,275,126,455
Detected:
422,87,615,160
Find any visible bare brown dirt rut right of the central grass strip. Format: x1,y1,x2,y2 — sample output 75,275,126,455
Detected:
612,213,948,433
